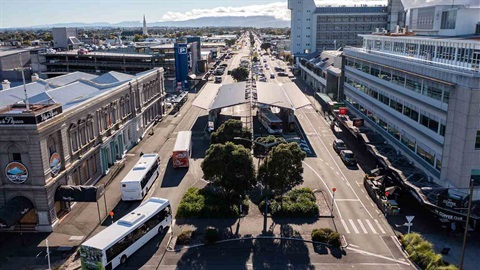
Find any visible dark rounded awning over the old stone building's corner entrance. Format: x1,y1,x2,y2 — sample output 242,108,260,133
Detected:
0,196,33,228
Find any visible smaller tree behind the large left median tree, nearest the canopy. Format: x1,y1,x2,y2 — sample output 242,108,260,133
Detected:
211,119,252,148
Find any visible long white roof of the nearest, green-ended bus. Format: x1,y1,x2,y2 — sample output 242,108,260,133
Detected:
82,197,170,250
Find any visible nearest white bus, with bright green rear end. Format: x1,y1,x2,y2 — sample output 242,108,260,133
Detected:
80,197,172,270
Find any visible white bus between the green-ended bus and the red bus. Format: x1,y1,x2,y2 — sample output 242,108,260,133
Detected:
120,154,160,201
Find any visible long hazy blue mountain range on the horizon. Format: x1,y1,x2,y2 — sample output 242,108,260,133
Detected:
15,16,290,28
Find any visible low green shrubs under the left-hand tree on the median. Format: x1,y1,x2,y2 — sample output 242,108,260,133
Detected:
177,187,244,218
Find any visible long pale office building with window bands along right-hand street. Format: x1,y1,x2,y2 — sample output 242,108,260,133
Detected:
344,5,480,207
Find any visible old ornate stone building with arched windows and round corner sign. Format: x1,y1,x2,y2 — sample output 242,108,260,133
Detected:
0,68,165,231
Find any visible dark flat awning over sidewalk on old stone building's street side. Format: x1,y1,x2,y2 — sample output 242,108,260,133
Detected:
55,185,104,202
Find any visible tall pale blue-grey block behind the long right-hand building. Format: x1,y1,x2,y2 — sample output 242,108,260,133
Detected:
288,0,405,56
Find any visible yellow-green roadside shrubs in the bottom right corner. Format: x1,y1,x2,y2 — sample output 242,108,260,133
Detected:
400,233,458,270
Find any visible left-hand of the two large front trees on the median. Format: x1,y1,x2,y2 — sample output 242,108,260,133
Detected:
201,142,256,199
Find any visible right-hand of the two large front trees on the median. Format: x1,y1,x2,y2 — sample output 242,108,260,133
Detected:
258,142,306,197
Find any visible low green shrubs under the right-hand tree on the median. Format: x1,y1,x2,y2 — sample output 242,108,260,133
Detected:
258,188,319,218
